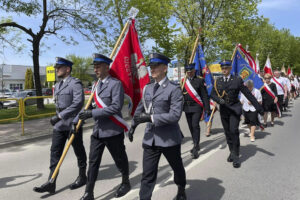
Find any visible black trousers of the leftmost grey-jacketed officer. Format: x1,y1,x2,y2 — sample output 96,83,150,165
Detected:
50,128,87,173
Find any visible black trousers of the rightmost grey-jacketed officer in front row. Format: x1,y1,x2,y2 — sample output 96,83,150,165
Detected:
140,144,186,200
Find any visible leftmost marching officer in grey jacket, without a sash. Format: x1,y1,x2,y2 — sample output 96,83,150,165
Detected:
33,57,87,193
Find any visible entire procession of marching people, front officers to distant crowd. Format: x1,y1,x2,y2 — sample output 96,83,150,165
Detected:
33,53,299,200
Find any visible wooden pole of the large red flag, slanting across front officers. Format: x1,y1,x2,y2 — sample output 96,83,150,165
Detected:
50,19,131,183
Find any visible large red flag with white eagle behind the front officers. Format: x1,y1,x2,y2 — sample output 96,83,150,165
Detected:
110,19,150,116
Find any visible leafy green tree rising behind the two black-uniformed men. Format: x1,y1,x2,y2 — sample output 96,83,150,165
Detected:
171,0,260,61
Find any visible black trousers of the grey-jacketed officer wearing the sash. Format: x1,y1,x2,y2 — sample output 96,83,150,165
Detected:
85,133,129,192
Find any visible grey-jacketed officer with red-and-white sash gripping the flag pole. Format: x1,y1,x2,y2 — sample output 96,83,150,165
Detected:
79,54,131,200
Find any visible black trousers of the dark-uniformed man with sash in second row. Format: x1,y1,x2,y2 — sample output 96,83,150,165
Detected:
185,110,203,145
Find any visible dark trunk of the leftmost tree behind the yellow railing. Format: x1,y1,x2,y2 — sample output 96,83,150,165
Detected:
32,39,44,109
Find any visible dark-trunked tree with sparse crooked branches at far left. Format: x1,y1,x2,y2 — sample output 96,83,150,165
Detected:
0,0,101,109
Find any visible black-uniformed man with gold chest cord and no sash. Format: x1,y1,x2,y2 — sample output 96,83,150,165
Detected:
211,60,263,168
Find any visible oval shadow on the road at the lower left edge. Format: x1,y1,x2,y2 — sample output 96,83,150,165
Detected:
0,173,42,188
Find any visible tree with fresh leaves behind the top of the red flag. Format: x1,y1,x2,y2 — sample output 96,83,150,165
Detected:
90,0,178,57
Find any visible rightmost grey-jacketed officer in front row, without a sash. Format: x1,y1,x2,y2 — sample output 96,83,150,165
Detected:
129,53,186,200
